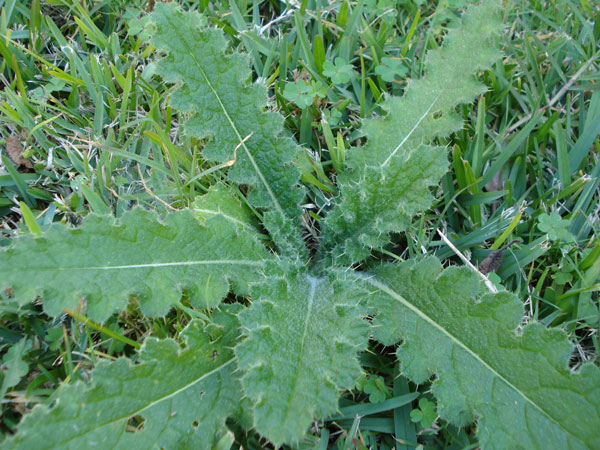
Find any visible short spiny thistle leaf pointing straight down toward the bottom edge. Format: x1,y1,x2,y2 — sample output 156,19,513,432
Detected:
235,269,368,446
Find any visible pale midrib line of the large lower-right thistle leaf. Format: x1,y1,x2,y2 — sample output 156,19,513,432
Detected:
359,274,586,446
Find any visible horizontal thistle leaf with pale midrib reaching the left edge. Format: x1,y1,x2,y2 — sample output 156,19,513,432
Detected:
0,208,270,321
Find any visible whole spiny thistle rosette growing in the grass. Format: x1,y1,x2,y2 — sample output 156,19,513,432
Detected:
0,0,600,449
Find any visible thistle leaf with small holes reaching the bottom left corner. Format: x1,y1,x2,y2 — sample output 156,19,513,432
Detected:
2,305,241,449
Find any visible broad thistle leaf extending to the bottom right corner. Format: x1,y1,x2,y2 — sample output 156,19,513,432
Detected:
367,258,600,448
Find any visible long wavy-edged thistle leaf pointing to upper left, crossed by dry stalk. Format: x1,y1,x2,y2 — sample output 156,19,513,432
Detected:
147,3,304,252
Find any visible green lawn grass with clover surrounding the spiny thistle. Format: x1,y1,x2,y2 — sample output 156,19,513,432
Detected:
0,0,600,449
